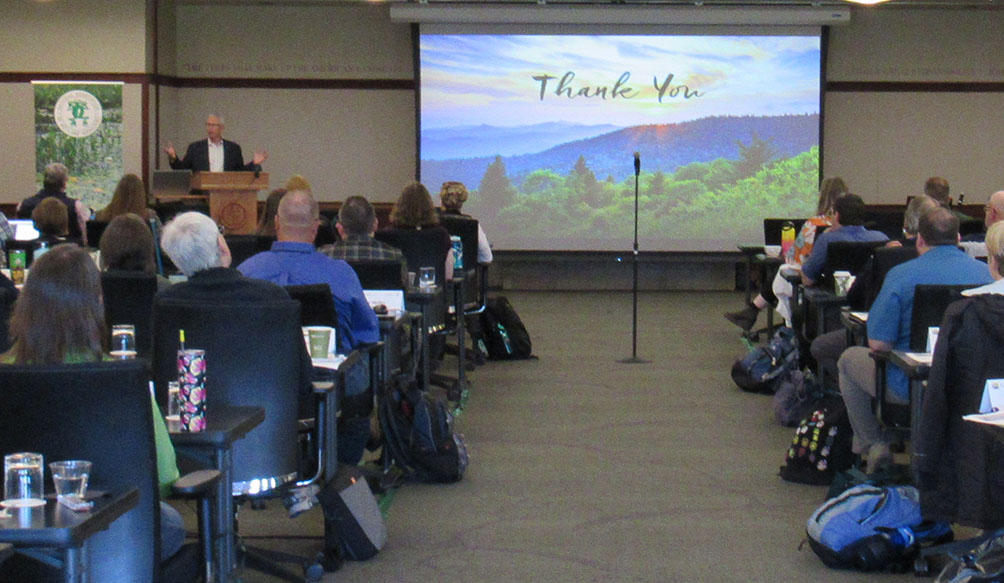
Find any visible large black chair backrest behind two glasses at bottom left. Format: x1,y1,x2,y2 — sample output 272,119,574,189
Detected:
0,360,160,583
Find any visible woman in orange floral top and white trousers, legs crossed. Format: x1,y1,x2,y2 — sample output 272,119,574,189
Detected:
724,177,847,332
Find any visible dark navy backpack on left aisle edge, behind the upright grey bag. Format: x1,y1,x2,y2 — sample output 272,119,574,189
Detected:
380,380,468,482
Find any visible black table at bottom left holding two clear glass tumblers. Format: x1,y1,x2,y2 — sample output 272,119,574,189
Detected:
0,488,140,583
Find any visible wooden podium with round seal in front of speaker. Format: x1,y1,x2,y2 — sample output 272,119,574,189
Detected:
192,172,268,235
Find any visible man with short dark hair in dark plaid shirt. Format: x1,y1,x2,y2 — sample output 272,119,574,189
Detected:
318,197,408,283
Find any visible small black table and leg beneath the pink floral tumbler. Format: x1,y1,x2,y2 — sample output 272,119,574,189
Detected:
171,406,265,583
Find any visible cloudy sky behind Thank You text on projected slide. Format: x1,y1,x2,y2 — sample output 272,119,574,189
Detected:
421,35,819,129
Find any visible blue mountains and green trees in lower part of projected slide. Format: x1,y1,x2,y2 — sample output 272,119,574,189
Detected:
422,113,819,250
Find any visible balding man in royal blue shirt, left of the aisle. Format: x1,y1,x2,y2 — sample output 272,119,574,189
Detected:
237,191,380,354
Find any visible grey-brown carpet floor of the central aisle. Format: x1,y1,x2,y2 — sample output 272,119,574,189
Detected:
193,292,931,583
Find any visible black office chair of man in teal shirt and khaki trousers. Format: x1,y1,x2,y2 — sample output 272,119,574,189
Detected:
871,284,977,431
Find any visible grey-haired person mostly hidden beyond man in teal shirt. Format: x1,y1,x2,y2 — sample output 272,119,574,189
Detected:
809,196,938,378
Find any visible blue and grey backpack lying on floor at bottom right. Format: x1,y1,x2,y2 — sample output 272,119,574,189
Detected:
805,485,952,571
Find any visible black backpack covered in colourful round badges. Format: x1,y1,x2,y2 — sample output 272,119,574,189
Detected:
778,395,854,486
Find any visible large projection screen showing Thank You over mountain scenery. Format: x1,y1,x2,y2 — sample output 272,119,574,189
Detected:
419,25,820,251
